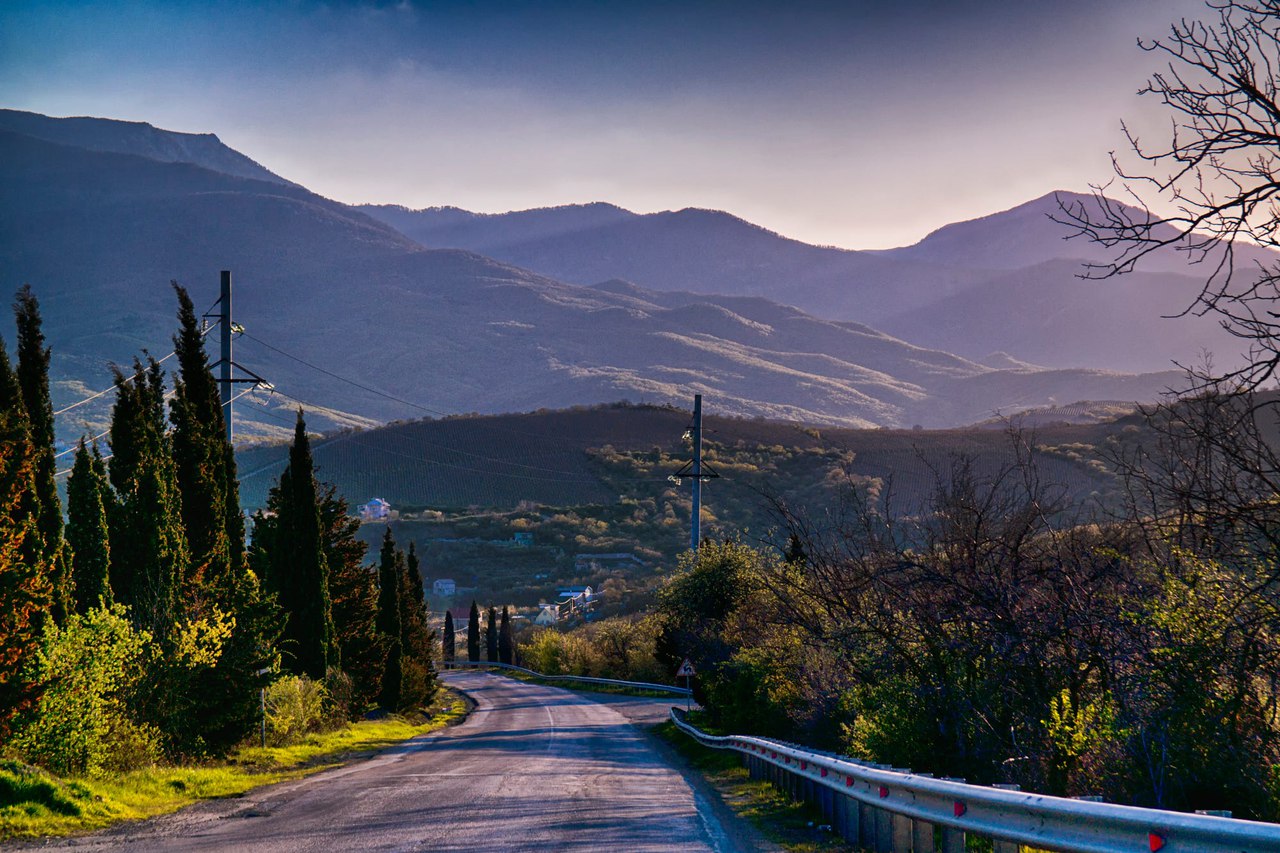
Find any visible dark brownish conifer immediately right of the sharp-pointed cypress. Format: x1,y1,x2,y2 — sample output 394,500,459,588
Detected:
320,484,388,712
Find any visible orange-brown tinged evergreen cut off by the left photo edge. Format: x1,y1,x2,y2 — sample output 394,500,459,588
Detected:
0,341,52,743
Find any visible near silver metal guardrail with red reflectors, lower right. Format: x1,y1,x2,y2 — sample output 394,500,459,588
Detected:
671,708,1280,853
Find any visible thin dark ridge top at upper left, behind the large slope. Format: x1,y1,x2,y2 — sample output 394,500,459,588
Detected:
0,109,291,184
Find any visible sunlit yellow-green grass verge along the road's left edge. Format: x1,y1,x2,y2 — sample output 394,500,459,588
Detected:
0,689,468,840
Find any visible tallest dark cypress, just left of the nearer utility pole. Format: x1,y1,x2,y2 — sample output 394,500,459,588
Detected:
169,282,234,596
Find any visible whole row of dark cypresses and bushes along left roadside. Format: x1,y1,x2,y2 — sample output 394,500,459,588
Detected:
0,283,436,772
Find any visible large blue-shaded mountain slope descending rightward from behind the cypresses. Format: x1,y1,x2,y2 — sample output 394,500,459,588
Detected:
0,112,1171,438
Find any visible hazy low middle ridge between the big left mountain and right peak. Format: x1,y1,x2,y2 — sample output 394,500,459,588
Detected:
362,204,984,325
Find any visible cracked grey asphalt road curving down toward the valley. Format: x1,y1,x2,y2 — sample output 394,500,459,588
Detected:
27,672,742,853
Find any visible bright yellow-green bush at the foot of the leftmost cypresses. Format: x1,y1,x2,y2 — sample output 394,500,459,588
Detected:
12,606,160,774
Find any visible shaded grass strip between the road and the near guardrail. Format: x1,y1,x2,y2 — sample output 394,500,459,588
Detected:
654,722,861,853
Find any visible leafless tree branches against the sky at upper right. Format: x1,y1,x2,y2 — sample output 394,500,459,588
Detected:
1057,0,1280,389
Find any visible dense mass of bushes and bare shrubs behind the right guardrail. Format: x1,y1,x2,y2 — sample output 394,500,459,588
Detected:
547,402,1280,820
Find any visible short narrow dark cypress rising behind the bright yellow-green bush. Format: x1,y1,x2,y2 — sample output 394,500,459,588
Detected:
67,438,111,613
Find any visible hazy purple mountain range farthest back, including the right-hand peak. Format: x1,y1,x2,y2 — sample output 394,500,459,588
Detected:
364,192,1280,371
